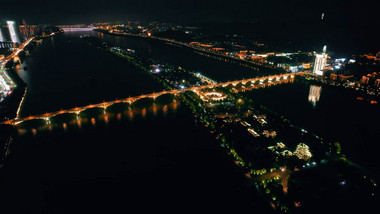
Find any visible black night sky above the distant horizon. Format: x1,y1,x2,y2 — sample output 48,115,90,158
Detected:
0,0,379,24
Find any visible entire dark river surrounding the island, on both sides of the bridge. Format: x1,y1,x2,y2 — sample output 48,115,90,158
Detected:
0,32,379,213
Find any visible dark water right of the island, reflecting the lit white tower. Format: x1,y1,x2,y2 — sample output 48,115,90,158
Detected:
246,80,380,179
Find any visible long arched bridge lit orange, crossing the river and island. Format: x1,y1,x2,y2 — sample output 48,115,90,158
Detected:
2,72,306,125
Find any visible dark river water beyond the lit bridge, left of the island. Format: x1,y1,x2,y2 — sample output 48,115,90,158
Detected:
14,32,163,116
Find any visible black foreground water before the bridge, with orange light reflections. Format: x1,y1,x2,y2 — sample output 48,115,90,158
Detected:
0,102,271,213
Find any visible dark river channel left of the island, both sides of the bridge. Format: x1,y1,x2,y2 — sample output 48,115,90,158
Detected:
0,33,271,213
